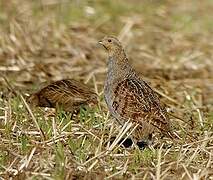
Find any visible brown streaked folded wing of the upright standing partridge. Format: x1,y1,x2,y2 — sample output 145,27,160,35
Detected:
112,78,169,130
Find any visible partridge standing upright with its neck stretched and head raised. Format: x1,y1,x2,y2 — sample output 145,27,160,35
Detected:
99,36,171,145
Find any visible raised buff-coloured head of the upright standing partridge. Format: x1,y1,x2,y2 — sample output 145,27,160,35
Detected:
99,36,122,55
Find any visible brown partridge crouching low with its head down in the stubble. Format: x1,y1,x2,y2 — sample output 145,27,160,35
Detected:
27,79,98,112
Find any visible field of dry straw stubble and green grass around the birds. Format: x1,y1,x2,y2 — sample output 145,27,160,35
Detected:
0,0,213,180
